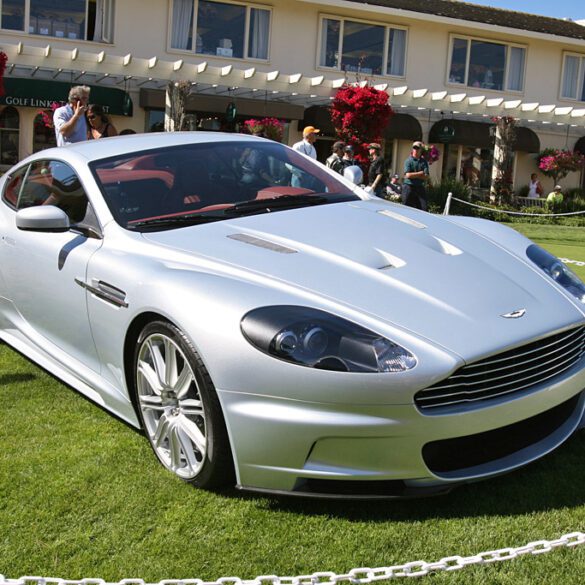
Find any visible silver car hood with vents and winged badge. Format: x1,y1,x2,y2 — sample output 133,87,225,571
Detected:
144,201,583,360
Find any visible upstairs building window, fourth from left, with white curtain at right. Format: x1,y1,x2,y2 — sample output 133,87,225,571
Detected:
449,37,526,91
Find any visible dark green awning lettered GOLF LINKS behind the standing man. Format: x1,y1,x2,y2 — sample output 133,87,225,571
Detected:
0,77,133,116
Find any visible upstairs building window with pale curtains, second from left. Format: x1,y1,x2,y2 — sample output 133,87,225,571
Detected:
171,0,271,61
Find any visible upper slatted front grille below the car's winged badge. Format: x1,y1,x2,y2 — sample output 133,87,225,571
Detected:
414,326,585,414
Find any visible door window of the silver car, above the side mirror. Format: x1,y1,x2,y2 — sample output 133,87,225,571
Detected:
16,160,88,223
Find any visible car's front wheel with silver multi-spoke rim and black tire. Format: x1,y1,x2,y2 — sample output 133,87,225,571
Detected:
133,321,234,489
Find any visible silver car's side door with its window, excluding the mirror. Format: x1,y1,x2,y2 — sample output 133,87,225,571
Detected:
0,160,102,372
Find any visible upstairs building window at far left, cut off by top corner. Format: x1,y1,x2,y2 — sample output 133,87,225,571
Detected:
2,0,114,43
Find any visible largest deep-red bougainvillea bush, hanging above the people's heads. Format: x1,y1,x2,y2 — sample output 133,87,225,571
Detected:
330,84,394,162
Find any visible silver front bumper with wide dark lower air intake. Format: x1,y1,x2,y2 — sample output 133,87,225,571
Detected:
218,360,585,498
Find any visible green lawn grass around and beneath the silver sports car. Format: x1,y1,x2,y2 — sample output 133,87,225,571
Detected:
0,225,585,585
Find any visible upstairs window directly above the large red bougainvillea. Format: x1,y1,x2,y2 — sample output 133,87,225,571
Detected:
319,17,406,77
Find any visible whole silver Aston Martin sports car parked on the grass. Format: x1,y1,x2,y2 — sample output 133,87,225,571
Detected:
0,132,585,497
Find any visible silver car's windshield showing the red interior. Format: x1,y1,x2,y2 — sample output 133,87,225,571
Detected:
90,139,359,231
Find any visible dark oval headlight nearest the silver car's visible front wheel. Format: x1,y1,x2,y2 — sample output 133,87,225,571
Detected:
241,305,416,373
